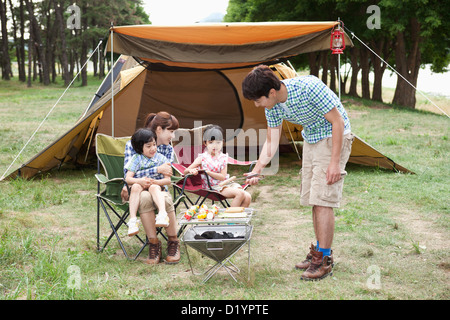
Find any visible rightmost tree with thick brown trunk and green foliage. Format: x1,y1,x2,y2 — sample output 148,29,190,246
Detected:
382,0,450,108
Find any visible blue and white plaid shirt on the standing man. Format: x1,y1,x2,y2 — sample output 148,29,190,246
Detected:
265,75,351,143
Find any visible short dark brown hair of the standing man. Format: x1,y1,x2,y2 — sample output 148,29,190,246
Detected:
242,65,281,100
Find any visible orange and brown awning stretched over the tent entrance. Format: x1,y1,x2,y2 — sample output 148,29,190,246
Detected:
106,21,352,69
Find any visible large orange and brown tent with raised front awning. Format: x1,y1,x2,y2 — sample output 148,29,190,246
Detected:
2,22,409,178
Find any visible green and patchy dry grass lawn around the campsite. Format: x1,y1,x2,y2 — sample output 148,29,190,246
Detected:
0,75,450,301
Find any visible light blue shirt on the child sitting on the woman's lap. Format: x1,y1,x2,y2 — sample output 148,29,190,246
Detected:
124,152,167,180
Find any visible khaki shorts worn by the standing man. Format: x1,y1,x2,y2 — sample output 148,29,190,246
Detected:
300,133,354,208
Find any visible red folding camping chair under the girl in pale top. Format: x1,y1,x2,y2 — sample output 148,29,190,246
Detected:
172,125,255,209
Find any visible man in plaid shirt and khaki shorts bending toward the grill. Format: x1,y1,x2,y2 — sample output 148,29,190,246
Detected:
242,65,353,280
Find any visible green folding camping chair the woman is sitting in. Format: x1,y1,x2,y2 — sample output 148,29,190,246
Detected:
95,134,185,260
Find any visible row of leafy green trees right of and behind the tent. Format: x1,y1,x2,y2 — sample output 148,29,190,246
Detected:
225,0,450,108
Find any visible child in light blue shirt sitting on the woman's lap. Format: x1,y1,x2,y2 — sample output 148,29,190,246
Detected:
125,128,170,236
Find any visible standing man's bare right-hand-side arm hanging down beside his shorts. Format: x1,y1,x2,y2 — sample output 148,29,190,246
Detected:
325,107,345,184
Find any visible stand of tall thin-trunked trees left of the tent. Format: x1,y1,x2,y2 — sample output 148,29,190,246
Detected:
0,0,150,86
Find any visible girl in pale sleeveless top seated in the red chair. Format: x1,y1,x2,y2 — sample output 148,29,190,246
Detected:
184,125,251,207
